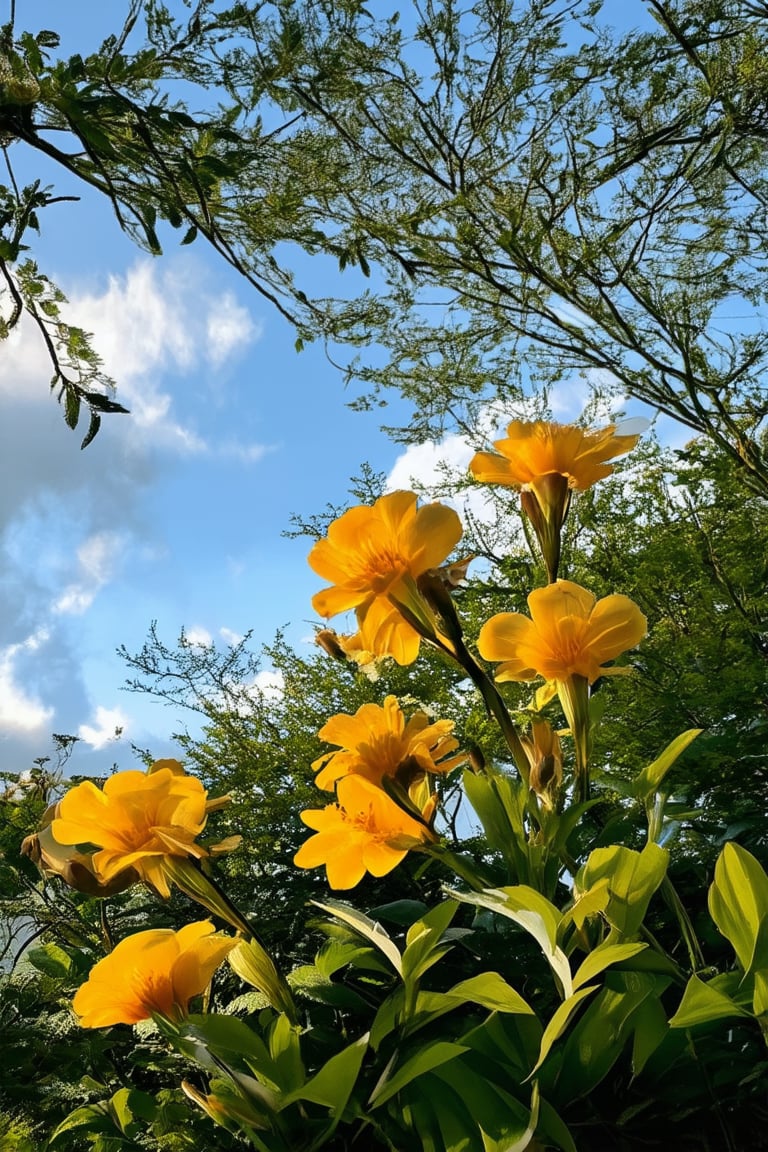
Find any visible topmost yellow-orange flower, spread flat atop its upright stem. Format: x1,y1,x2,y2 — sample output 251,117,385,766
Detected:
470,420,639,491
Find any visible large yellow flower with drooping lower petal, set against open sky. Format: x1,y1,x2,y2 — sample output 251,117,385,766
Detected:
309,492,462,665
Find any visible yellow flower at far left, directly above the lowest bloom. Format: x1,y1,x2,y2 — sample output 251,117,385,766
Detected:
51,761,207,896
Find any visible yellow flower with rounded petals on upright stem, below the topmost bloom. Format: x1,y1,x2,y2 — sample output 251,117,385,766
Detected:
478,579,647,683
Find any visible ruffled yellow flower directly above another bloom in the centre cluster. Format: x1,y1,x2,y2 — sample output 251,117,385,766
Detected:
312,696,465,789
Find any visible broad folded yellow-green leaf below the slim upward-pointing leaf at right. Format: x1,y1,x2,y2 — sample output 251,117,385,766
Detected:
576,844,669,937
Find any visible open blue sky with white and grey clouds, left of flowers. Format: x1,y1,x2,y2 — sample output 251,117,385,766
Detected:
0,0,672,773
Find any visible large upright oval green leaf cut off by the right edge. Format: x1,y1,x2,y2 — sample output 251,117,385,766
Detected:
709,843,768,973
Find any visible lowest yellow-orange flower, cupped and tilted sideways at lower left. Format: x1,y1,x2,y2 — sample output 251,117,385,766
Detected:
73,920,237,1028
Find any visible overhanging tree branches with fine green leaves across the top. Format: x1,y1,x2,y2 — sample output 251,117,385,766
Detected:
3,0,768,494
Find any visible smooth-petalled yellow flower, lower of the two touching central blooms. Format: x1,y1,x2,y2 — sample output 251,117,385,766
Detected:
294,775,436,888
